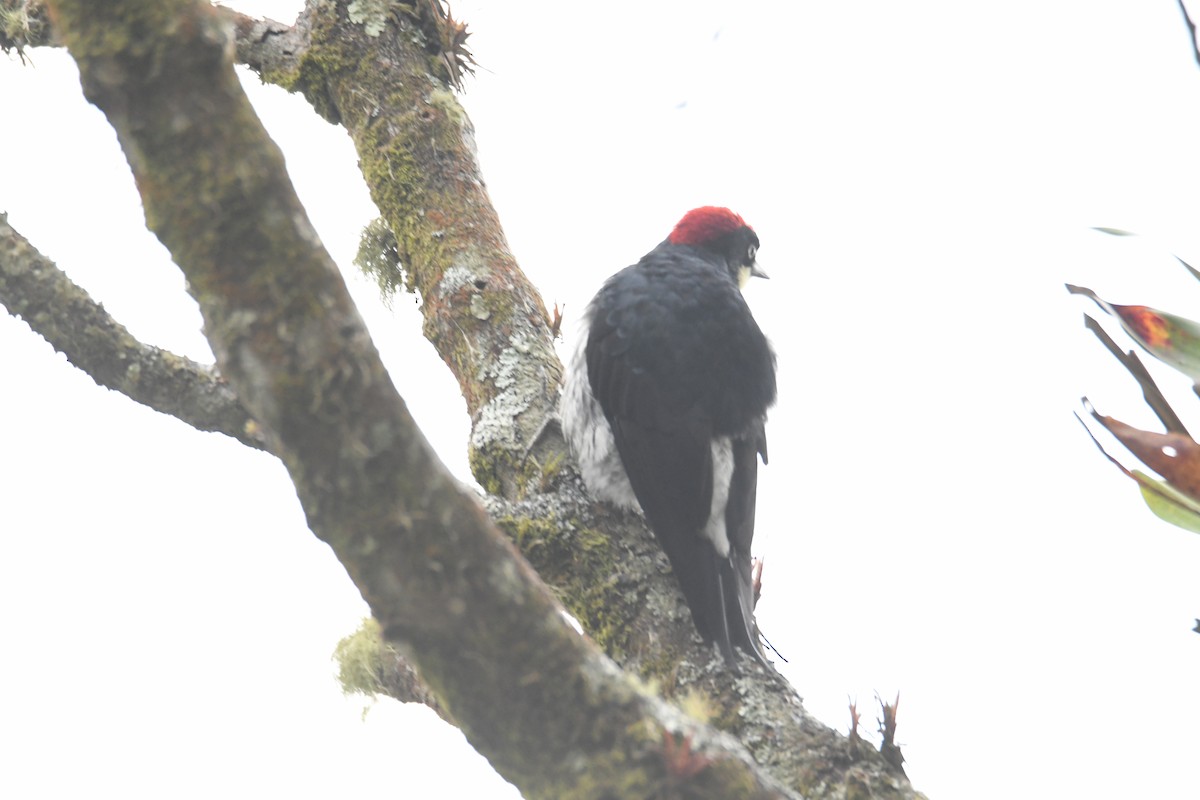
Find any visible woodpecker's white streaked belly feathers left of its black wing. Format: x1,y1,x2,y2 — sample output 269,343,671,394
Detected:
558,312,641,509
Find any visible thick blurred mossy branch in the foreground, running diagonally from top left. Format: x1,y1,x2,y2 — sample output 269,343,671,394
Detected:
52,0,816,798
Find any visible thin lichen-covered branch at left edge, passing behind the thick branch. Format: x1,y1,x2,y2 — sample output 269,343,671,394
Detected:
0,213,263,449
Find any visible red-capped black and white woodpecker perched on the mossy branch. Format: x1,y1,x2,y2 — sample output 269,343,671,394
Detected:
560,206,775,667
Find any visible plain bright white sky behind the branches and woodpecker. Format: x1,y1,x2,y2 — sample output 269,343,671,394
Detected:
0,0,1200,800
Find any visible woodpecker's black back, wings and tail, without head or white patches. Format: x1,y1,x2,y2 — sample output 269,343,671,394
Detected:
586,253,774,657
